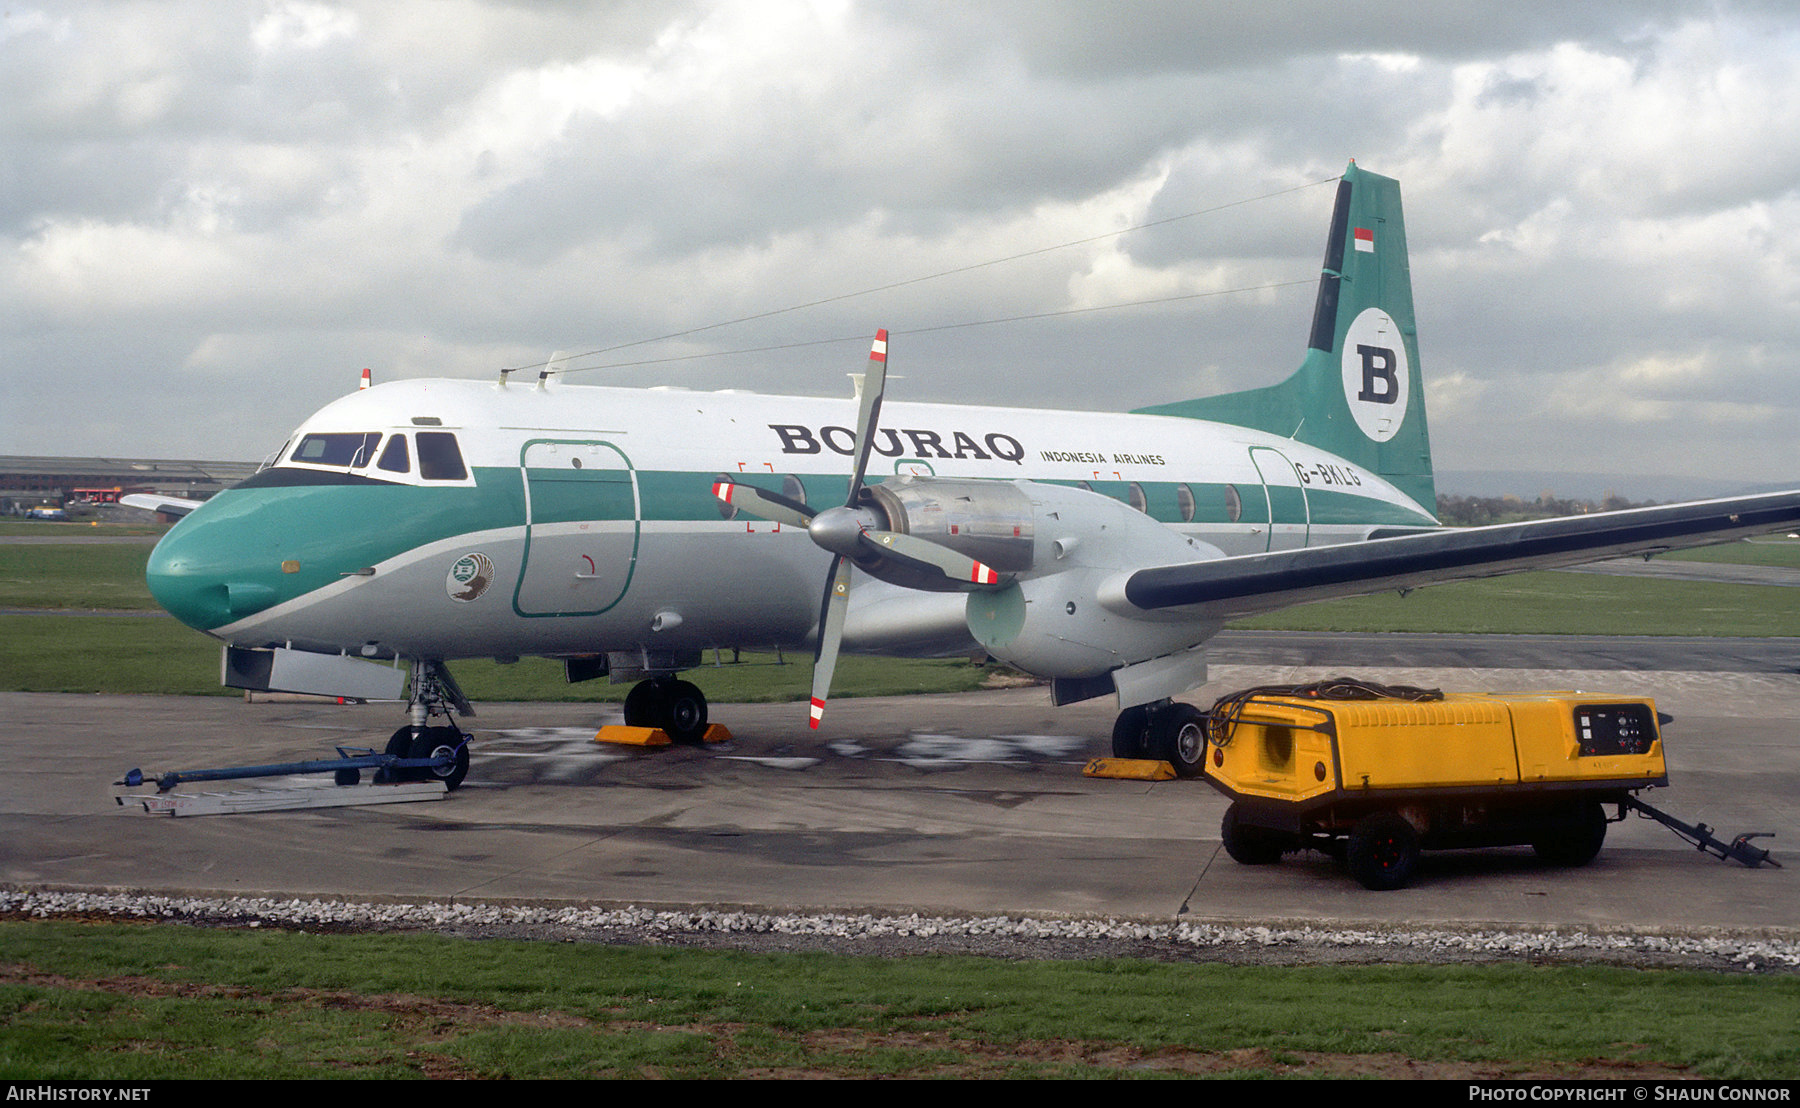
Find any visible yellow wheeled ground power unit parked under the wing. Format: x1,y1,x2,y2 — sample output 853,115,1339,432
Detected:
1206,685,1669,889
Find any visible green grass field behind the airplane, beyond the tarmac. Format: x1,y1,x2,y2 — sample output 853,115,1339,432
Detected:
0,523,1800,703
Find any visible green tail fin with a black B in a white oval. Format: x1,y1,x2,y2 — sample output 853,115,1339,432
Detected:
1139,162,1436,516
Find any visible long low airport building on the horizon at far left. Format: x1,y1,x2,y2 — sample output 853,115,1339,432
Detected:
0,455,256,516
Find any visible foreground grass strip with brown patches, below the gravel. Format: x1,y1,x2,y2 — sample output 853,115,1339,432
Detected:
0,923,1800,1081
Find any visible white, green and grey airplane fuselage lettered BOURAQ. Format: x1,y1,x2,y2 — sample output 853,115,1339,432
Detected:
149,372,1435,658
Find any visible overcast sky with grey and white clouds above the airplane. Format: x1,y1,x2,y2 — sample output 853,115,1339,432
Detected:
0,0,1800,495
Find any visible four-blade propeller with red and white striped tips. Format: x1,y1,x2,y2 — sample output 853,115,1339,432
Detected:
713,331,1001,728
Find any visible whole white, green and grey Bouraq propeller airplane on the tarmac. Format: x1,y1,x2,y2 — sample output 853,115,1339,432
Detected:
136,164,1800,784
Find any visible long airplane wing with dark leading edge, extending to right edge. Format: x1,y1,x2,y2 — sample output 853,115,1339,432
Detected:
1103,491,1800,619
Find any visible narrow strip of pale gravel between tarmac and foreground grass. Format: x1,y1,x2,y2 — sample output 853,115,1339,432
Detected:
0,890,1800,973
